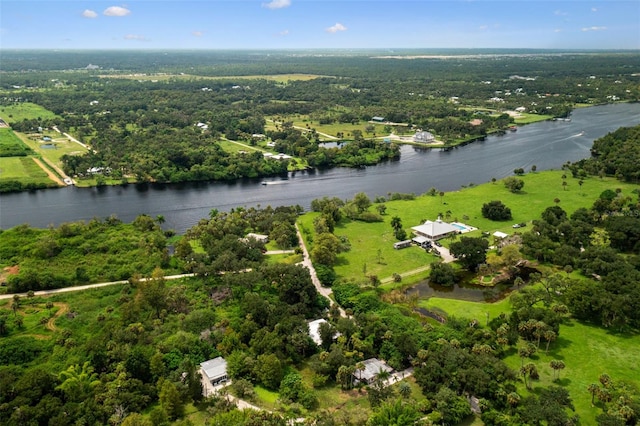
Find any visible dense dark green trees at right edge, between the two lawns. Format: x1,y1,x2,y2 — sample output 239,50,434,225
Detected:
522,190,640,330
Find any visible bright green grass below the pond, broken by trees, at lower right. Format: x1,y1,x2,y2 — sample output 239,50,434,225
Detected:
419,297,640,425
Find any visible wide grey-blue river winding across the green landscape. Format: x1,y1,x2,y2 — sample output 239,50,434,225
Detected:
0,103,640,233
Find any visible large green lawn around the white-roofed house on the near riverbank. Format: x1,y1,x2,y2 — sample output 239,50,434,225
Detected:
299,171,638,280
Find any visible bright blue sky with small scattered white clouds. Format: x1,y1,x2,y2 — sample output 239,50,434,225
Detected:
0,0,640,49
